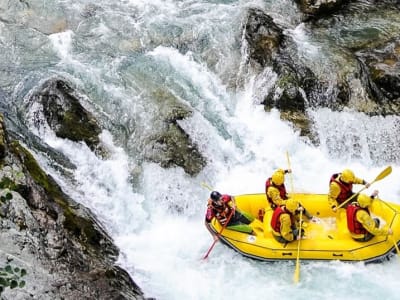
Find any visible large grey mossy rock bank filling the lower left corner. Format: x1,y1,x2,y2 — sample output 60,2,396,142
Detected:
0,115,144,299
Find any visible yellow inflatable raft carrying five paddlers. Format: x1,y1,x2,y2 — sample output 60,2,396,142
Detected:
206,194,400,262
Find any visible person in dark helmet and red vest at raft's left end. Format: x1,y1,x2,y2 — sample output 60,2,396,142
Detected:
205,191,254,234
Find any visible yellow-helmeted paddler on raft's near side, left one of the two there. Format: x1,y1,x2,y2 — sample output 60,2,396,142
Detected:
271,199,303,243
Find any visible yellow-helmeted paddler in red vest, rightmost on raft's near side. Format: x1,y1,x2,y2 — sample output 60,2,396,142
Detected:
346,191,393,242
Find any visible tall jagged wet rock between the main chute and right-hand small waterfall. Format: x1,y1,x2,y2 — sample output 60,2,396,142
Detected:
241,9,322,134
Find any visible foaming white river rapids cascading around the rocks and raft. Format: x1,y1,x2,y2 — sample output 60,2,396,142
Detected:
0,0,400,300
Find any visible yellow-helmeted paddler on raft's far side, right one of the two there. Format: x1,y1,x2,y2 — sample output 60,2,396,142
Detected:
328,169,370,212
